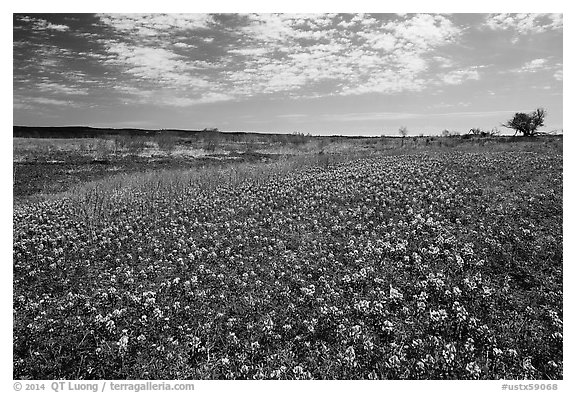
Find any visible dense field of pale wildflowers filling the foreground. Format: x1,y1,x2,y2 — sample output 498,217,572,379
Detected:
13,152,563,379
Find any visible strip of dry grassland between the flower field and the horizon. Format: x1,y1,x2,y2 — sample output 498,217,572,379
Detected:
13,134,562,204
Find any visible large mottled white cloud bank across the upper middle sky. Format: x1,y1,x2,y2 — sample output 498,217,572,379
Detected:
91,14,473,103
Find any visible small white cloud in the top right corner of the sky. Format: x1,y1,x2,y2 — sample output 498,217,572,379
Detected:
486,14,563,34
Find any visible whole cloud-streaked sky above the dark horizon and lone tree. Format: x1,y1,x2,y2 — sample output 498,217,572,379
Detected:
13,13,563,135
